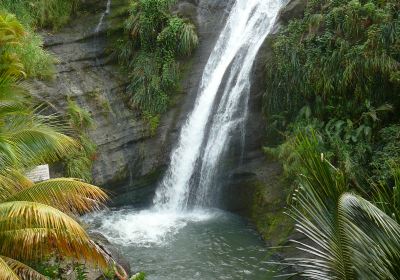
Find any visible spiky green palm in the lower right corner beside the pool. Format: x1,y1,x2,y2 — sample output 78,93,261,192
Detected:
289,135,400,280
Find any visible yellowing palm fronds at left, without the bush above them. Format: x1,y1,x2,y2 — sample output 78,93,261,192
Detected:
0,69,114,279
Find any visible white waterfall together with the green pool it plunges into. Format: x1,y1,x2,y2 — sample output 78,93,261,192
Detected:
85,0,282,280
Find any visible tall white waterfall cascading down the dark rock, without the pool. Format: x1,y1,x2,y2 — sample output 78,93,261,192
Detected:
154,0,281,211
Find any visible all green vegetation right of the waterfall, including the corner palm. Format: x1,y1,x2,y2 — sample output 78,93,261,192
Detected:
263,0,400,279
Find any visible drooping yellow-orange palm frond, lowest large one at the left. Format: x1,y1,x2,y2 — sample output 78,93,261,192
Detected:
0,201,110,267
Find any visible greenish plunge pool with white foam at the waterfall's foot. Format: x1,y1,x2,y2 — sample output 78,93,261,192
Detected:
85,209,278,280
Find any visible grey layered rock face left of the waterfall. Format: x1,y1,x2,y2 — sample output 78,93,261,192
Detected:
32,0,232,205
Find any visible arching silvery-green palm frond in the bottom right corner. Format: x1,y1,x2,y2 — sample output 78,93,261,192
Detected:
339,193,400,279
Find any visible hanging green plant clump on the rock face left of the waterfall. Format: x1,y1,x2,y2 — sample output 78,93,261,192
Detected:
117,0,198,115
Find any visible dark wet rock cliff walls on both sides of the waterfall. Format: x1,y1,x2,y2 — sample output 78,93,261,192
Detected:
32,0,306,245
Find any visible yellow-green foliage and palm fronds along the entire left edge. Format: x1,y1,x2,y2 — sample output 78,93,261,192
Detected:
0,1,123,280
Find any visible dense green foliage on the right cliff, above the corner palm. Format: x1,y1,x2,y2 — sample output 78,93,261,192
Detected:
264,0,400,192
